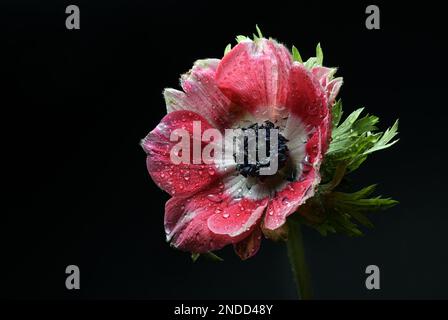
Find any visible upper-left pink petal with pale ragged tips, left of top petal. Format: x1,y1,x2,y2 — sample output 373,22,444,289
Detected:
163,59,237,129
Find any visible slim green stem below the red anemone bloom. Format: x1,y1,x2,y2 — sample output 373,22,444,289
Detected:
287,219,312,300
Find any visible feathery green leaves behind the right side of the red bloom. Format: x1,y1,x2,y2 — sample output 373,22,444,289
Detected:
299,100,398,236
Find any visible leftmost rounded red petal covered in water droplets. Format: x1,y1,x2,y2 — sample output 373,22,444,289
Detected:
142,111,226,195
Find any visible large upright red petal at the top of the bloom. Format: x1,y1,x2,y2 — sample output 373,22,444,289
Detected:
216,39,292,119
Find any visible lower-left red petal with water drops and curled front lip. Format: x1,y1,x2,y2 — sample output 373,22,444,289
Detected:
165,182,267,253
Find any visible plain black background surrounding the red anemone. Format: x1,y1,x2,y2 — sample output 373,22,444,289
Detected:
0,0,448,299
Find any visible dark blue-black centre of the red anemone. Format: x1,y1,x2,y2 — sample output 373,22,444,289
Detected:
233,121,288,177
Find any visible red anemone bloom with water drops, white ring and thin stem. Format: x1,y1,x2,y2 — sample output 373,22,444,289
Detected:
142,28,398,295
